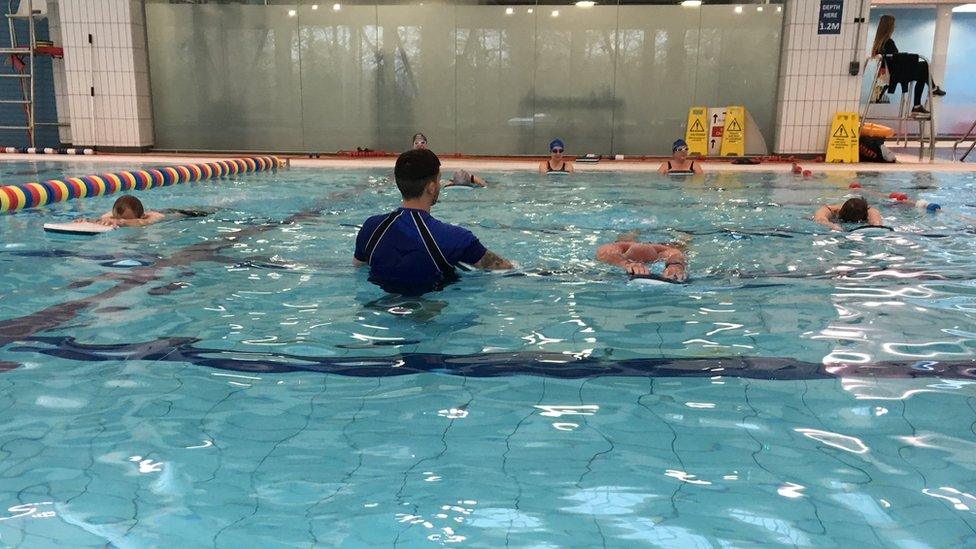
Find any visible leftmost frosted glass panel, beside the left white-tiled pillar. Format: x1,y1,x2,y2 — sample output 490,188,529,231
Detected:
146,4,304,151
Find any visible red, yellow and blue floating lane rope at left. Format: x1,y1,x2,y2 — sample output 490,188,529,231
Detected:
0,156,286,212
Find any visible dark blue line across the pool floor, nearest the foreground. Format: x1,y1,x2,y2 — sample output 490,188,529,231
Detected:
0,336,976,380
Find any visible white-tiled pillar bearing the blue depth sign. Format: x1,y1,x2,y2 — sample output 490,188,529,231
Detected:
773,0,870,154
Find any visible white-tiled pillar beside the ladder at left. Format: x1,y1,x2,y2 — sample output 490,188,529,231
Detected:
50,0,153,147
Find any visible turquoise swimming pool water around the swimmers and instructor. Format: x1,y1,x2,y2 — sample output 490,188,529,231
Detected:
0,165,976,547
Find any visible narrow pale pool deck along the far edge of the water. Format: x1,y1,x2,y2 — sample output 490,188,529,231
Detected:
0,147,976,173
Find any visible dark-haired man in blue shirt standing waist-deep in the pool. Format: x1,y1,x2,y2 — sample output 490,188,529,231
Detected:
353,149,512,294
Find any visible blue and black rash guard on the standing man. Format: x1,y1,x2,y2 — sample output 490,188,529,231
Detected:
354,208,487,294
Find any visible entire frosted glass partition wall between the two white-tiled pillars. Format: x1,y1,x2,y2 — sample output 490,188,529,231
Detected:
146,0,782,155
